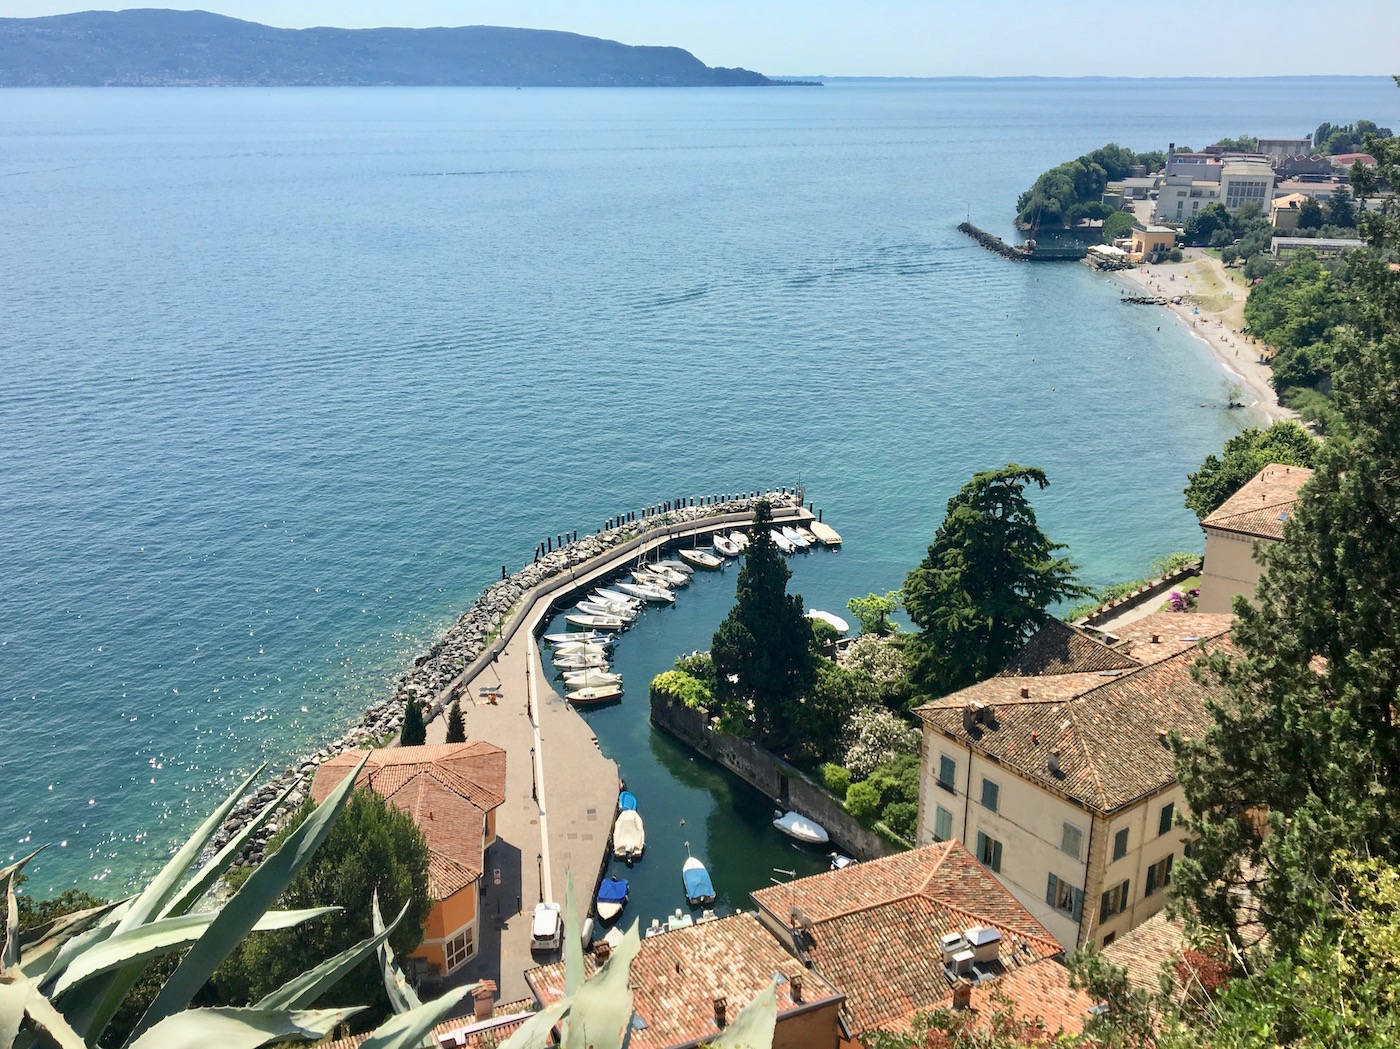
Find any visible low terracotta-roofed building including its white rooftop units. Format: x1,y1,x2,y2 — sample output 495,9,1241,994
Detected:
750,842,1093,1046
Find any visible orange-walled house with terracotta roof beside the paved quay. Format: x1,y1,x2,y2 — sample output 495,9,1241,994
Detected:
311,739,505,976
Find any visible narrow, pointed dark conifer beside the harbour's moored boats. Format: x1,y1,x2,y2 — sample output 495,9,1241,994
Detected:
710,500,816,751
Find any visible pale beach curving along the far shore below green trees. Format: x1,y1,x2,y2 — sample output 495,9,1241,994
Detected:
1114,248,1298,422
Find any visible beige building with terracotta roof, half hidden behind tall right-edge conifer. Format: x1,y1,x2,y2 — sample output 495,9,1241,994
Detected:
1197,459,1313,612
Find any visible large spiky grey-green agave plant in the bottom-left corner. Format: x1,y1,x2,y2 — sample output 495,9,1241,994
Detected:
0,760,475,1049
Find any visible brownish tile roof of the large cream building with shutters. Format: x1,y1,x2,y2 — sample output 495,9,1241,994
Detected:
916,627,1229,812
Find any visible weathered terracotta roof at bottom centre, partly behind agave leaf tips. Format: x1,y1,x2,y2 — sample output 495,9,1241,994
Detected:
525,913,843,1049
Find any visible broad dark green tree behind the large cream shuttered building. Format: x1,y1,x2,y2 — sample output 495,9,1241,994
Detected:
904,462,1089,696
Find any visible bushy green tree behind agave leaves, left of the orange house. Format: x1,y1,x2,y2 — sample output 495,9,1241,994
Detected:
214,789,433,1008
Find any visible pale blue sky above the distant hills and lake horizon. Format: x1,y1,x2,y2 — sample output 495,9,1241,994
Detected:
8,0,1400,77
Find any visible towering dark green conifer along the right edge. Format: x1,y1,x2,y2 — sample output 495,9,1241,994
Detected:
1177,120,1400,951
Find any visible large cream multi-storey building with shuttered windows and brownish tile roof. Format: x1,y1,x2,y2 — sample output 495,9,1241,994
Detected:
916,612,1232,947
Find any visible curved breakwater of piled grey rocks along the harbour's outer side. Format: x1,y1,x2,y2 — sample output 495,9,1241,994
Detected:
205,489,802,866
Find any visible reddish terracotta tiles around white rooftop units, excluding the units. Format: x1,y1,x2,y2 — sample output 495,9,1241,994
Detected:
753,842,1063,1032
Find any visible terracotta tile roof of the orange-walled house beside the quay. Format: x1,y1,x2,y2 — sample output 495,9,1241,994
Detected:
311,739,505,899
